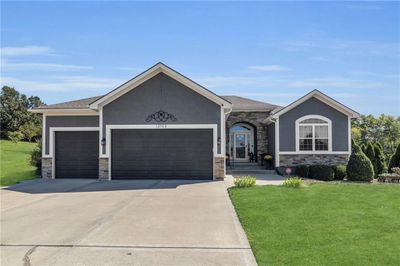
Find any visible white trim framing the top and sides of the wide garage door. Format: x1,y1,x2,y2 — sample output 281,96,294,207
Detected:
104,124,218,180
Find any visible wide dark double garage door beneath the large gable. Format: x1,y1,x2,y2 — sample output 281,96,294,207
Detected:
111,129,213,179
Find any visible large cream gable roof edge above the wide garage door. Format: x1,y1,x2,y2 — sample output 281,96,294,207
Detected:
89,63,231,109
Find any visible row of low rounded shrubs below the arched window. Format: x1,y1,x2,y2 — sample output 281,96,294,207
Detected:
296,164,346,181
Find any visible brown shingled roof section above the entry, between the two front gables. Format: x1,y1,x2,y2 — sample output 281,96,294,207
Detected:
221,95,280,112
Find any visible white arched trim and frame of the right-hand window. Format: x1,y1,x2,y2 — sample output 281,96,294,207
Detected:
294,115,332,154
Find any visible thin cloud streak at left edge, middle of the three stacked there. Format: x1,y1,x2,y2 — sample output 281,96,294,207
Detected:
2,61,93,71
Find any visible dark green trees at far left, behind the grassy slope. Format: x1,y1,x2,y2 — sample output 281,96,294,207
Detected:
0,86,43,138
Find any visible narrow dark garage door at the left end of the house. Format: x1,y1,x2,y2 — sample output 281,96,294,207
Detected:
55,131,99,178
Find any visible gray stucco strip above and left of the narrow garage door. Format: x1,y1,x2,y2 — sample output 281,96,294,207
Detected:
45,116,99,154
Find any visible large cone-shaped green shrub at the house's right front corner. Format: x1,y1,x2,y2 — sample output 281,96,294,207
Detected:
346,145,374,182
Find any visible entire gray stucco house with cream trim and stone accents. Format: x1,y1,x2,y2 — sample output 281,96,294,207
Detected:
32,63,359,180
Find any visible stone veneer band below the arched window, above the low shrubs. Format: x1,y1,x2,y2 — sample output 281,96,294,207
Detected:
279,154,349,166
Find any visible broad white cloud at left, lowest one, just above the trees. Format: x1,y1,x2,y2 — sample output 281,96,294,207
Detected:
1,76,122,92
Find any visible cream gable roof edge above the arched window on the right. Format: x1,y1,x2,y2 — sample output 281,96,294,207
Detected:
271,90,360,118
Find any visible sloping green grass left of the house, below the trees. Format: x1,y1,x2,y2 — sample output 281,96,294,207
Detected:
0,140,37,186
